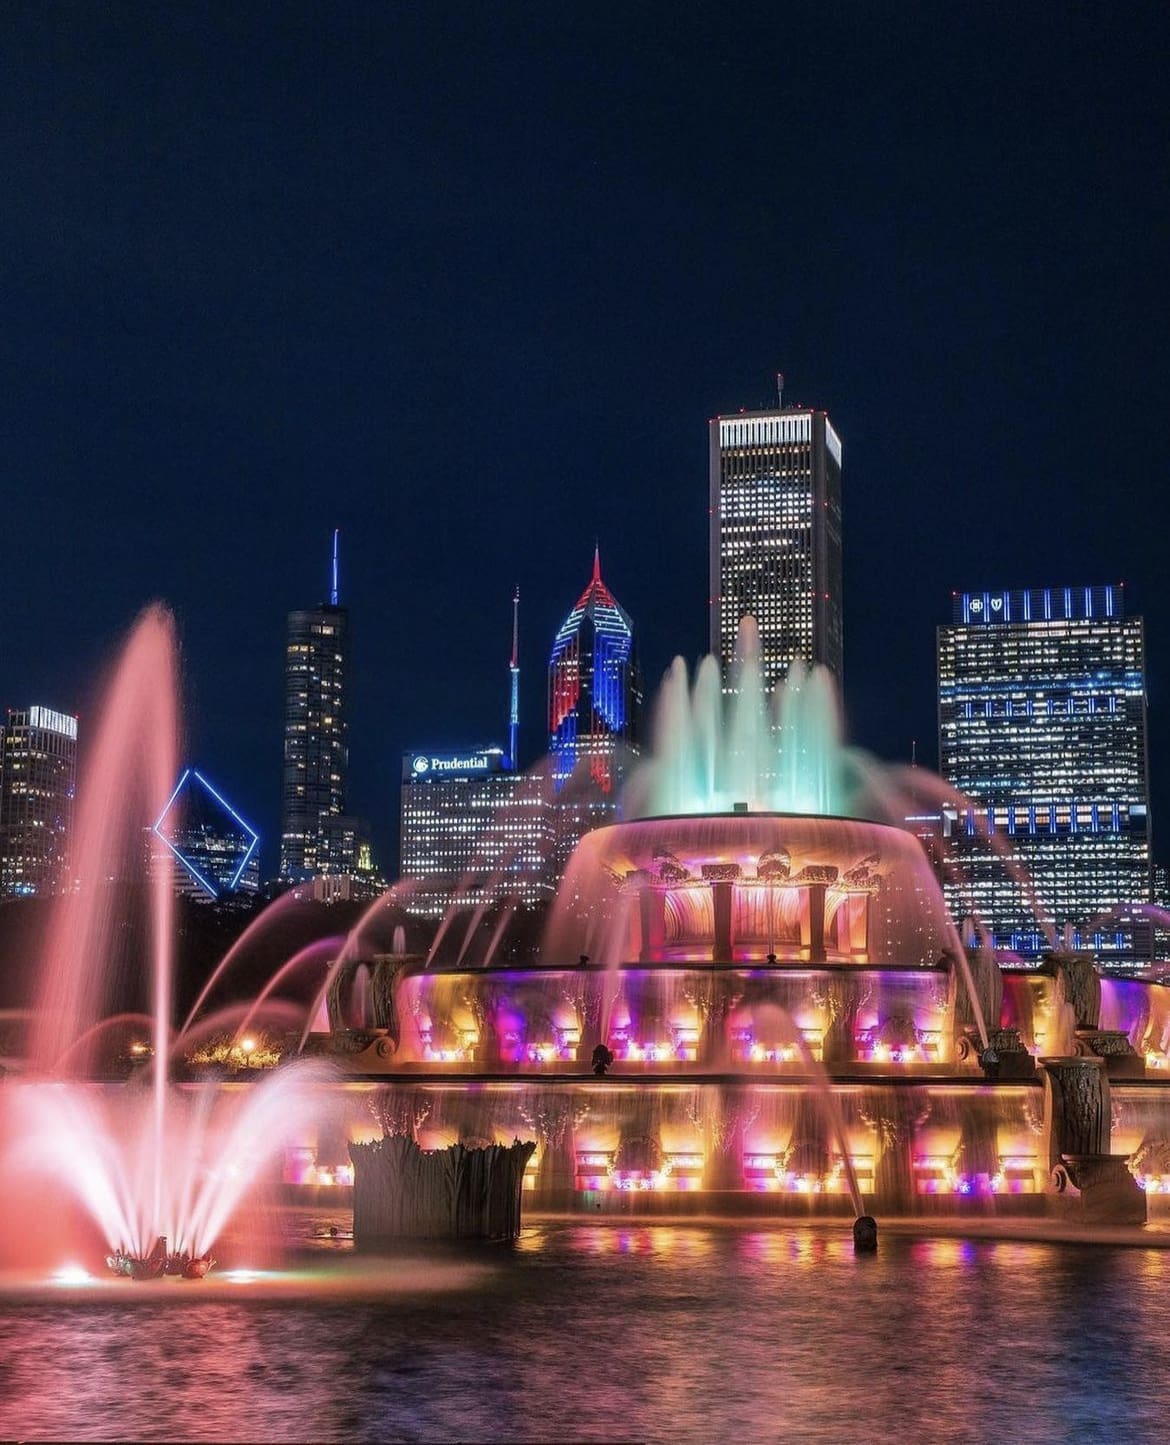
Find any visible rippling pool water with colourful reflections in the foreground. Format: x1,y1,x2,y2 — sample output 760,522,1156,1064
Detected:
0,1221,1166,1442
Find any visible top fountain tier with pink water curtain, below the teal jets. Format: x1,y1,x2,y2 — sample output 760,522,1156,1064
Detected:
547,814,958,968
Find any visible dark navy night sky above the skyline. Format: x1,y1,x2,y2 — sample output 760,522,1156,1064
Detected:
0,0,1170,871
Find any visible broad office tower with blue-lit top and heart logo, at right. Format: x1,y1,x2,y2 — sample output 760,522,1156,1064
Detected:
937,587,1151,957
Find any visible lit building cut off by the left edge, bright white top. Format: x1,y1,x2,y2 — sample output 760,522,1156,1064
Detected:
0,707,77,897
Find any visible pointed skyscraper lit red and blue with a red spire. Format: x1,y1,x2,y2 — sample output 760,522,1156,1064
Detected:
549,549,641,877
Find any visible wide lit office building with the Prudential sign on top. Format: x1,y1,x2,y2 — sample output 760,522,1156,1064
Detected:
400,747,553,918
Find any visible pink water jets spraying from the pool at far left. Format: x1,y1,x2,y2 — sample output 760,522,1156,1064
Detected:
0,607,324,1279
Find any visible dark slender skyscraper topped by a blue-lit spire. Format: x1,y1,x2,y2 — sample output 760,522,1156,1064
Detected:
280,532,355,883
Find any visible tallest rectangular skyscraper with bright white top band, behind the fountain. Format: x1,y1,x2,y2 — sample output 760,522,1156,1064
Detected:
709,377,842,691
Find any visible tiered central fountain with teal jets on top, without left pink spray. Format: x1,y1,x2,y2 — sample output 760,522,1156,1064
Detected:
314,627,1170,1231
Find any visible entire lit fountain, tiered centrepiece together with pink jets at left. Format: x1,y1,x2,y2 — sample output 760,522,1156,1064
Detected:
0,608,1170,1277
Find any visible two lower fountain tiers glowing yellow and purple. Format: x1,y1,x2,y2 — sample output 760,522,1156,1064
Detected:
306,958,1170,1222
